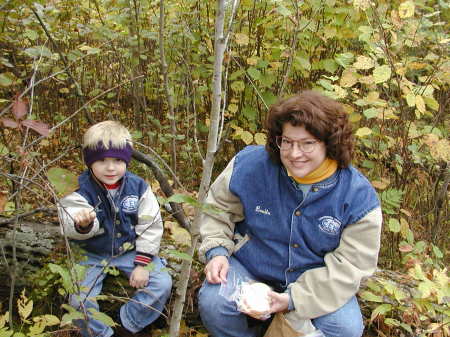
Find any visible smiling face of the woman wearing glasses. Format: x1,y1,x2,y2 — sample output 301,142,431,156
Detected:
280,123,327,178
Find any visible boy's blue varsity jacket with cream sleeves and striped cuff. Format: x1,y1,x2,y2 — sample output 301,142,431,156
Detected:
58,170,163,265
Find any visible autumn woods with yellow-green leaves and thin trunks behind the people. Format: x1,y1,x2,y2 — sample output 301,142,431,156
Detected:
0,0,450,336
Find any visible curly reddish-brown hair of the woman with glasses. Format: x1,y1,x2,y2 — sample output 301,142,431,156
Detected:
266,90,353,168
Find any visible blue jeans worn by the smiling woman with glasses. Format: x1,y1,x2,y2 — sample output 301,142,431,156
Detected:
198,257,364,337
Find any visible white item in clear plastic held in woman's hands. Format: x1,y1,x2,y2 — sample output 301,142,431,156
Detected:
239,282,271,316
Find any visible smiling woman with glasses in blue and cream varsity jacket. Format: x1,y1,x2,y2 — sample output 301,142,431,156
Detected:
199,91,382,337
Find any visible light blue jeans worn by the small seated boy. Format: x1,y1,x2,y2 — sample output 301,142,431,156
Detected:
70,251,172,337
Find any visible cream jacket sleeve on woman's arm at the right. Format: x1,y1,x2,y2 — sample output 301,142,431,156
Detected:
289,207,382,319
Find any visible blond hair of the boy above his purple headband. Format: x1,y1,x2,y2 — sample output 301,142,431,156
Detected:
83,121,133,149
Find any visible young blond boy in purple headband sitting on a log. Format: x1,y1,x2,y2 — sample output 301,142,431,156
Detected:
59,121,172,337
